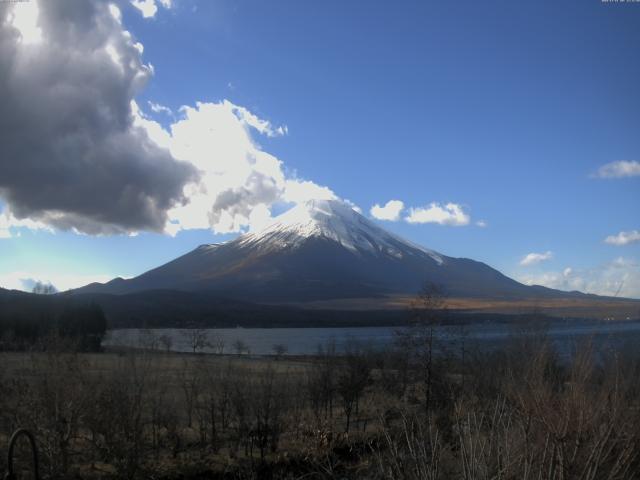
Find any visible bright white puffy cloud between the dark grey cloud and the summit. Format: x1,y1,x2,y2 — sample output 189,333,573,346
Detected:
132,100,338,235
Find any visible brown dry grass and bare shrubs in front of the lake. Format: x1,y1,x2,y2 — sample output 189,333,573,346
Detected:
0,319,640,479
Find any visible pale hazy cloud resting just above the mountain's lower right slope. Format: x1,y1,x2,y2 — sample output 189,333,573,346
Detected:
514,257,640,298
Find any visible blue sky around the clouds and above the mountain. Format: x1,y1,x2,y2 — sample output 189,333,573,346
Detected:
0,0,640,298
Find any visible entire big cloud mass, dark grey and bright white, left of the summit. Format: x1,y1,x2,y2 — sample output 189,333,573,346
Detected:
0,0,335,237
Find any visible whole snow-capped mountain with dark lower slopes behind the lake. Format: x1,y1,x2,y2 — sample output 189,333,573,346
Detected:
76,201,584,302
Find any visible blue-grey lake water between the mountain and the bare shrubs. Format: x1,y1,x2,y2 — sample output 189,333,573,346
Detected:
103,320,640,355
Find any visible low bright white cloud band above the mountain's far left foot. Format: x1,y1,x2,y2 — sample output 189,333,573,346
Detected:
0,271,113,292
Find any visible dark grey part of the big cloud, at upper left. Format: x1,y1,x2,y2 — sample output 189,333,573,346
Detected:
0,0,196,234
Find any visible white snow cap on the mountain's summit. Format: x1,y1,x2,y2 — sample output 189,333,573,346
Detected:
238,200,443,264
